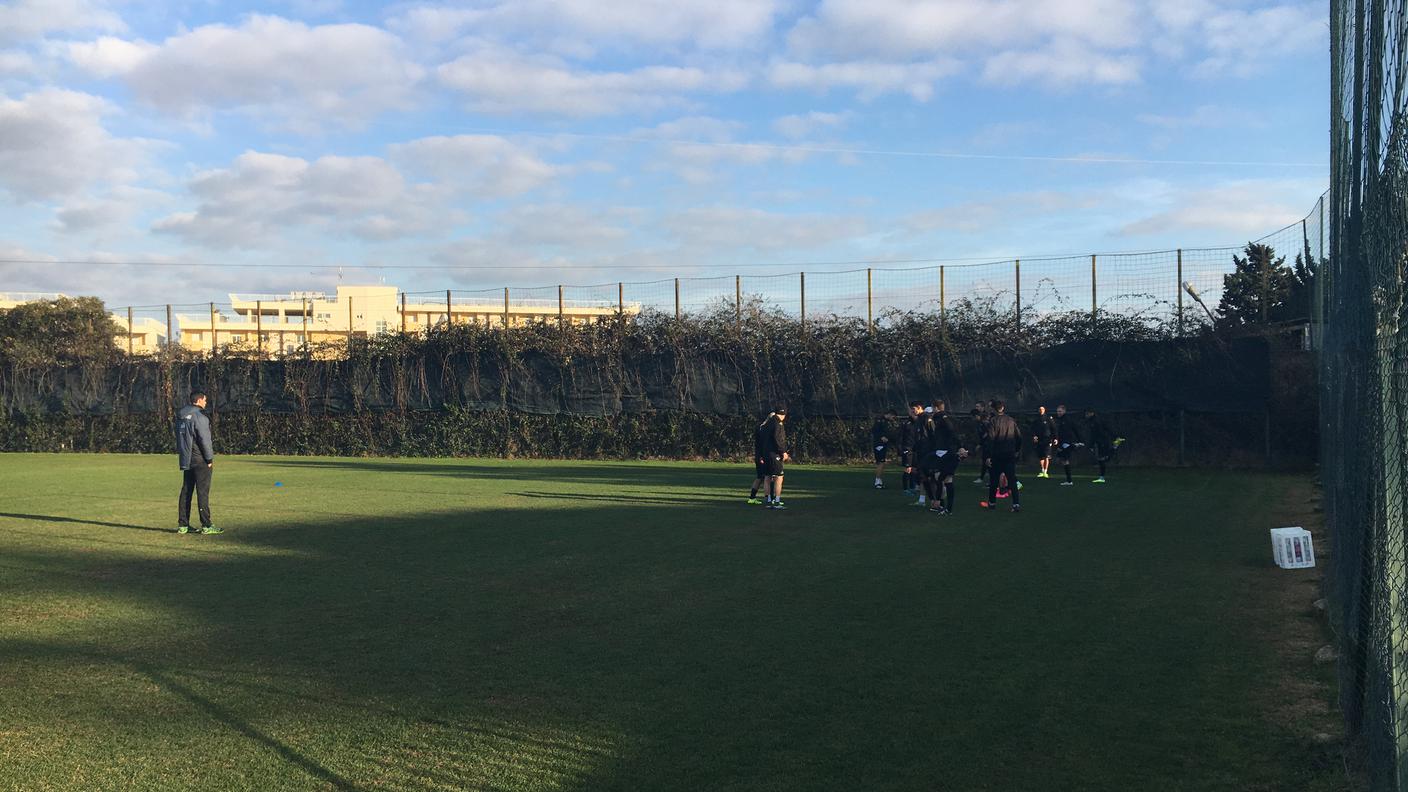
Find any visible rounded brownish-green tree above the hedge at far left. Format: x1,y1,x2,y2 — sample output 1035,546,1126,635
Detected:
0,297,122,366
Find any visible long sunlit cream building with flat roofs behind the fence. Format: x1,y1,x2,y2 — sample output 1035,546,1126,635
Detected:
177,286,641,354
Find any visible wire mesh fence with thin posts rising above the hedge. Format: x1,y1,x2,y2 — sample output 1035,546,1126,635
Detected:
60,199,1328,357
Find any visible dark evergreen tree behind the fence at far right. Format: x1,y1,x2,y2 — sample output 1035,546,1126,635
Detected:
1218,242,1315,326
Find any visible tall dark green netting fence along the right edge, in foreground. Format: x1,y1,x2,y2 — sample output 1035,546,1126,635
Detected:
1318,0,1408,792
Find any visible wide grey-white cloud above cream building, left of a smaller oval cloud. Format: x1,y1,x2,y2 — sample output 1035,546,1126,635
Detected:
153,151,453,248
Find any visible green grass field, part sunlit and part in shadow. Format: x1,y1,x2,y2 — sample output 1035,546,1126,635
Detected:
0,455,1345,791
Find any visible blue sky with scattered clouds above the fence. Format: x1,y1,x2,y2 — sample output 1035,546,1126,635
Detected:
0,0,1329,304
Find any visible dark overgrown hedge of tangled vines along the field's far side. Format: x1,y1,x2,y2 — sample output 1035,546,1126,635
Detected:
0,266,1314,462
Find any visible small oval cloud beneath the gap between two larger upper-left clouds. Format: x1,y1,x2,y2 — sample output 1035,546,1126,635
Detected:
390,135,560,197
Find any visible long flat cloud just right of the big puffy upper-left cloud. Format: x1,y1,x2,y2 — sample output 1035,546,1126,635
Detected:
438,49,748,117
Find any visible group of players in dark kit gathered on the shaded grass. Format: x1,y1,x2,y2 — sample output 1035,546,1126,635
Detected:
748,399,1124,516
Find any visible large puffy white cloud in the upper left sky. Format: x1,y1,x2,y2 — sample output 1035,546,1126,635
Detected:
69,16,422,130
